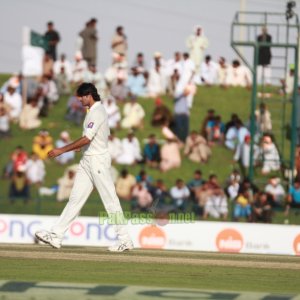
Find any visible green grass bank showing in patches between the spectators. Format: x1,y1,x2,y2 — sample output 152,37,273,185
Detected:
0,75,298,223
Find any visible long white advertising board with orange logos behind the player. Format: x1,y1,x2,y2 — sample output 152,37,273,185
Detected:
0,214,300,255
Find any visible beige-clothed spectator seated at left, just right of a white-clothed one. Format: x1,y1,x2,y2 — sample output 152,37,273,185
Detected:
19,99,42,130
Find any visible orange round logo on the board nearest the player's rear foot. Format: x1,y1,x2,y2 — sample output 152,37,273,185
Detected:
139,225,167,249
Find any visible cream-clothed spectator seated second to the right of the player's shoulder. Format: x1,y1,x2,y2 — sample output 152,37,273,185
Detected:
121,96,145,128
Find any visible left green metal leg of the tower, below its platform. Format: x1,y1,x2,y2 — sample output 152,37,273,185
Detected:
248,43,259,181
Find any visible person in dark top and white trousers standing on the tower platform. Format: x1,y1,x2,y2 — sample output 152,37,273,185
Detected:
257,26,272,85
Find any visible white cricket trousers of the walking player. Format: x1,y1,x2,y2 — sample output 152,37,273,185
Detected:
51,153,130,240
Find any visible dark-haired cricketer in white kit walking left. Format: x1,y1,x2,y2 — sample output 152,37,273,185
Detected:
35,83,133,252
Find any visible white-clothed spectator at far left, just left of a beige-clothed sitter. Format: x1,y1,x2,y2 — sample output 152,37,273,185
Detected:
4,85,22,122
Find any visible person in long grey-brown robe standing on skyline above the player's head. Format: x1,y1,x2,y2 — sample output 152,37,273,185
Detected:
79,18,98,66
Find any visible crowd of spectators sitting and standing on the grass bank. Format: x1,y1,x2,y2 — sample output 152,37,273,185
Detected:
0,19,300,222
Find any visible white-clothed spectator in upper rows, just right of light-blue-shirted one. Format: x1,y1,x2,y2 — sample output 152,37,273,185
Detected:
147,64,167,98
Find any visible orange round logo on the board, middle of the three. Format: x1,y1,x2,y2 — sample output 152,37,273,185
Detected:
216,228,244,252
